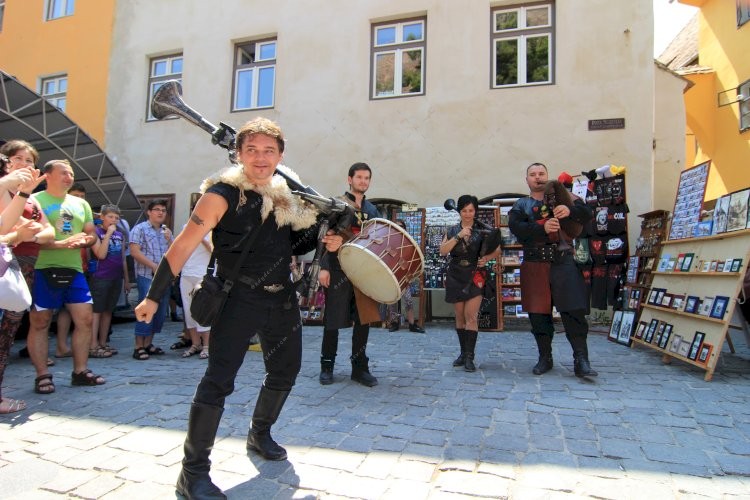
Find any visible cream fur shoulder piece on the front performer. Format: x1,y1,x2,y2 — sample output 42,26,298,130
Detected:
200,164,318,231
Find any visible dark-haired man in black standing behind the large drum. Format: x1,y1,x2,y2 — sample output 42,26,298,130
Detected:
318,162,380,387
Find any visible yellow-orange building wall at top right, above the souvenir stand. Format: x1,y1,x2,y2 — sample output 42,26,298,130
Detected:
680,0,750,200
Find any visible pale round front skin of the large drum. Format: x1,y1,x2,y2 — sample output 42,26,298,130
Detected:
339,243,401,304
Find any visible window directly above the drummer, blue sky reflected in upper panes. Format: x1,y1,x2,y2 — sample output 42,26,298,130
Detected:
371,18,426,99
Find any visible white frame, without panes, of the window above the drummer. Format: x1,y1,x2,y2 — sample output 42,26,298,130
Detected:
370,17,427,99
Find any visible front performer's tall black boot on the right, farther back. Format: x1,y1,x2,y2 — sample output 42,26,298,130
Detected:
247,386,289,460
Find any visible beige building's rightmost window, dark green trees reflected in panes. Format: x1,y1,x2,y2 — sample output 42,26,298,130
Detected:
492,3,554,88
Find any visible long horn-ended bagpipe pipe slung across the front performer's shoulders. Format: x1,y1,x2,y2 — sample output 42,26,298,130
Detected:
151,80,356,307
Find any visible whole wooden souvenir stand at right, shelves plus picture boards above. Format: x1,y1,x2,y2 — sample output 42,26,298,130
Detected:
632,161,750,381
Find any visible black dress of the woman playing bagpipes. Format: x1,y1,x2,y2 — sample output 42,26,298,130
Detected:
445,223,483,304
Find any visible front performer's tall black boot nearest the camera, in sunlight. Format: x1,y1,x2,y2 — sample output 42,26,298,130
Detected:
175,403,226,500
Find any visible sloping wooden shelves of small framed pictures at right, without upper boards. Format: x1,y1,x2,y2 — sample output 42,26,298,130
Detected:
631,229,750,381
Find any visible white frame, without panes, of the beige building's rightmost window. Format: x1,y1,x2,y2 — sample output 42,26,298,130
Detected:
490,2,555,89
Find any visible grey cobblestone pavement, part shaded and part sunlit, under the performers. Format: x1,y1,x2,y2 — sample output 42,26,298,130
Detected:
0,323,750,500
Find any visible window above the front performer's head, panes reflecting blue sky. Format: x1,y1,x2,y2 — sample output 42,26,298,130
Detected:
232,40,276,111
